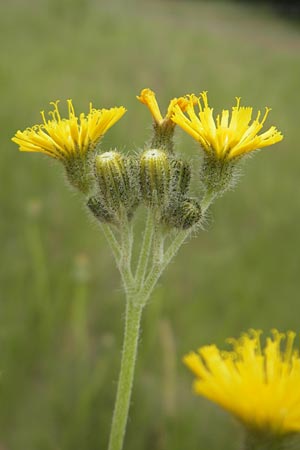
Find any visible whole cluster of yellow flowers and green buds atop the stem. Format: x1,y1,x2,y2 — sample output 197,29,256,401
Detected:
12,89,282,229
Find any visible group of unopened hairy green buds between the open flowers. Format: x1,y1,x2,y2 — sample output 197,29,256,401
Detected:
87,143,201,229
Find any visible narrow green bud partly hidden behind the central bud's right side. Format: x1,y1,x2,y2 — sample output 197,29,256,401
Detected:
170,159,191,200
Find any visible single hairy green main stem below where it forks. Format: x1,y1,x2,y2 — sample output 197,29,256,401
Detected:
108,298,143,450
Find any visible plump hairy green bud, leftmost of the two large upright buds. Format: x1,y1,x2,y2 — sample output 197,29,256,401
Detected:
95,151,139,218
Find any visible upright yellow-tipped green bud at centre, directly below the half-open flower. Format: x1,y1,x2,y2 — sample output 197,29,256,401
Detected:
140,149,170,207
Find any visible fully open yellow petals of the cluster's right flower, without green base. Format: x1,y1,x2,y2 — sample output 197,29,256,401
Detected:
172,92,283,160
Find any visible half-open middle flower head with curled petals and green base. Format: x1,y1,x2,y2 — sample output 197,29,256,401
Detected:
137,88,189,153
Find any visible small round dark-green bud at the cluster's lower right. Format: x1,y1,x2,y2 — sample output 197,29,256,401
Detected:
162,198,201,230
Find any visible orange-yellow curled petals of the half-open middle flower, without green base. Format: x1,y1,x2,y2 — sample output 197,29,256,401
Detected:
137,89,189,126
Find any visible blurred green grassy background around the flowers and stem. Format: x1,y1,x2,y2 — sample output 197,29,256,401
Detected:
0,0,300,450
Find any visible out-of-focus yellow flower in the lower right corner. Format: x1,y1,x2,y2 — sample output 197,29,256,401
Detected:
184,330,300,435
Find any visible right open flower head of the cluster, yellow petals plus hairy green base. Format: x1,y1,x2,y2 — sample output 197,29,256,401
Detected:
172,92,283,197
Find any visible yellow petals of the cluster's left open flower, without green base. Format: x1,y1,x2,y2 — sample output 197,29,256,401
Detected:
12,100,126,161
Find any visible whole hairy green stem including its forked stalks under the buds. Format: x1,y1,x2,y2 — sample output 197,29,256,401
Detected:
103,195,214,450
